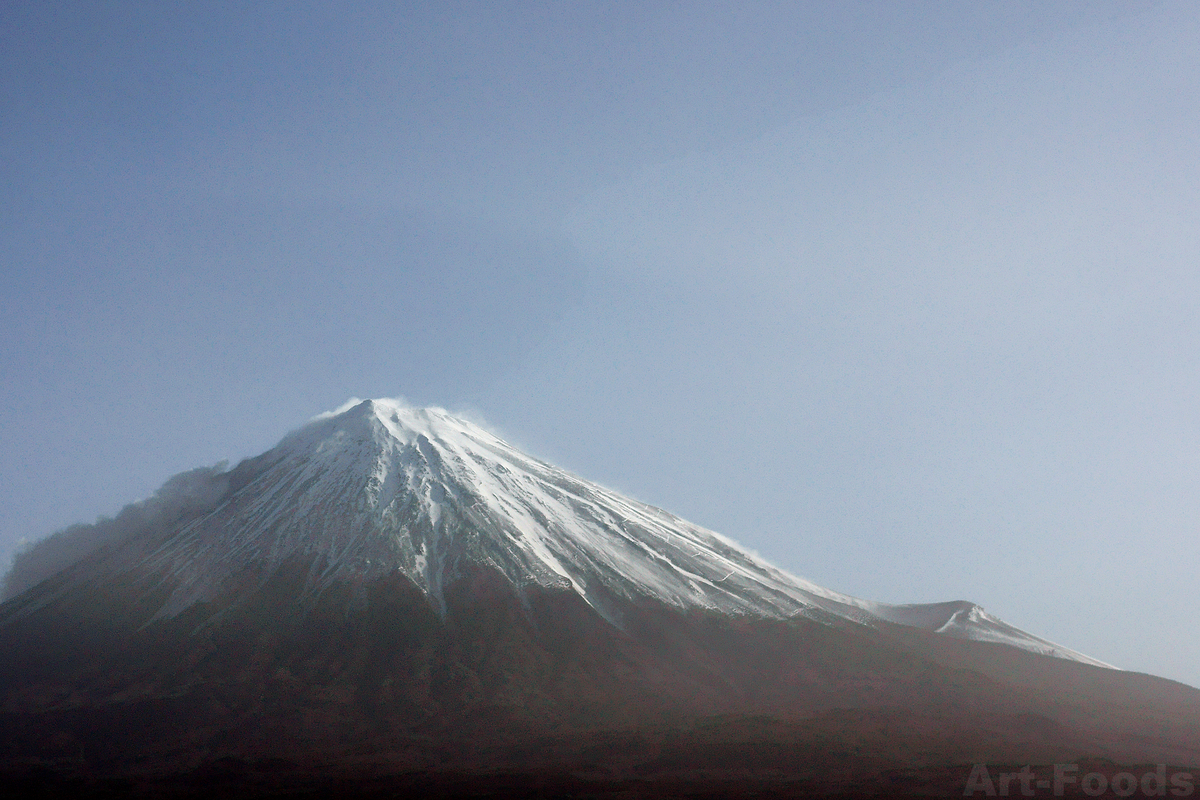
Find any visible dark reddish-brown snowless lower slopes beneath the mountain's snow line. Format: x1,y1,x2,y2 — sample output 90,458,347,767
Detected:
0,564,1200,798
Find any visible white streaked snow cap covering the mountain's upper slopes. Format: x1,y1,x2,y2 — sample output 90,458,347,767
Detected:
7,399,1108,666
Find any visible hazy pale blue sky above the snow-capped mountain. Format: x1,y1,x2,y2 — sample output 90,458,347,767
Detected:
0,0,1200,686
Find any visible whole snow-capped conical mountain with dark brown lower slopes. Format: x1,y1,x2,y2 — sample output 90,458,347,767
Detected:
0,399,1200,794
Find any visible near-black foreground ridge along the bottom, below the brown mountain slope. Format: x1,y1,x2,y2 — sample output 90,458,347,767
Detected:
0,758,1194,800
